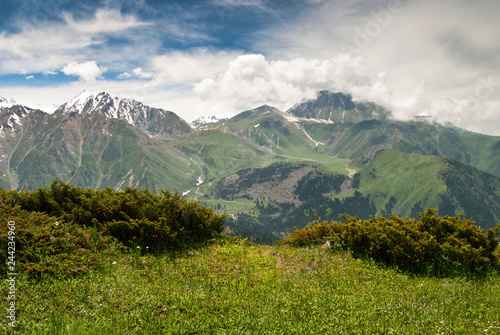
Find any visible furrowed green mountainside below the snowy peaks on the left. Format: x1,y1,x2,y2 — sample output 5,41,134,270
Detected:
0,107,197,191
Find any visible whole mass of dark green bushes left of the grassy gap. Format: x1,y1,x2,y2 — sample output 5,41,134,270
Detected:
0,180,224,274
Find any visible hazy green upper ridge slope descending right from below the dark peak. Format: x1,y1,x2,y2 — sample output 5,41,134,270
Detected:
303,120,500,176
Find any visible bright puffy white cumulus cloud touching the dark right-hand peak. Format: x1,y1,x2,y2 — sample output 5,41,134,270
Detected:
194,54,386,113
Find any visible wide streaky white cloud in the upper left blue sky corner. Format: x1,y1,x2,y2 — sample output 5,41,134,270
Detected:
0,9,150,73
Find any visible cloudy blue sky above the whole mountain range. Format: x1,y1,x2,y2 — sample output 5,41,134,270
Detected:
0,0,500,135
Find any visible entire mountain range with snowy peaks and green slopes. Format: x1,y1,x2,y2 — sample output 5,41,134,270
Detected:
0,91,500,241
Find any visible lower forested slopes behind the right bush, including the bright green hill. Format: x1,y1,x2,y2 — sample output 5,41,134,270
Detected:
214,150,500,242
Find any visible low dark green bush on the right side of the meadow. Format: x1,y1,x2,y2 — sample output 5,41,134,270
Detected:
280,209,500,276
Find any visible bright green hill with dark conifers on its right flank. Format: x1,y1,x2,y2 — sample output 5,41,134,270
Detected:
359,150,500,228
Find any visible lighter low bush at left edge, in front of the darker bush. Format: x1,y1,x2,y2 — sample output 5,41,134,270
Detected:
0,205,110,277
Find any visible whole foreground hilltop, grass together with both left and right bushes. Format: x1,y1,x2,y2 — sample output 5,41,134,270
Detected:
0,181,500,334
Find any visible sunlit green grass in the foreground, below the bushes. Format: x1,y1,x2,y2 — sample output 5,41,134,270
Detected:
0,238,500,334
